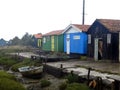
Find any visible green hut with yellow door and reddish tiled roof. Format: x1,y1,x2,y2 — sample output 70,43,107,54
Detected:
42,30,64,52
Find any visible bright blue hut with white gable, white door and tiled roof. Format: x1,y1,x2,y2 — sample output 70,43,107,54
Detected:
63,24,90,54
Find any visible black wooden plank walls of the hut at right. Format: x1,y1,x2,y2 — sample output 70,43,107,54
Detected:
87,21,119,62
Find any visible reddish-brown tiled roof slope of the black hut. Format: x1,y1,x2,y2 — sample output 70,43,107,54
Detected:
97,19,120,32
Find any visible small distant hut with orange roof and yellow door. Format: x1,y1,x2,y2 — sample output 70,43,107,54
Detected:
32,33,42,48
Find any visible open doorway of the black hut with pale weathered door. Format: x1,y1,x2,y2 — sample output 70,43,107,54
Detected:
94,38,103,60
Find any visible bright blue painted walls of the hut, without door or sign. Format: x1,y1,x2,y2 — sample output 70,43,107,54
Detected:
64,33,87,54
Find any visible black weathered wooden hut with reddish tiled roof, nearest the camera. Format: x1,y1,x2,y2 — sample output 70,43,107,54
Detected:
87,19,120,62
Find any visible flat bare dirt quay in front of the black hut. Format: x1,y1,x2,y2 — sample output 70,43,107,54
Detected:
47,59,120,75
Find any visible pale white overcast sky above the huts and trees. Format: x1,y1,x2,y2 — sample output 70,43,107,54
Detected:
0,0,120,40
